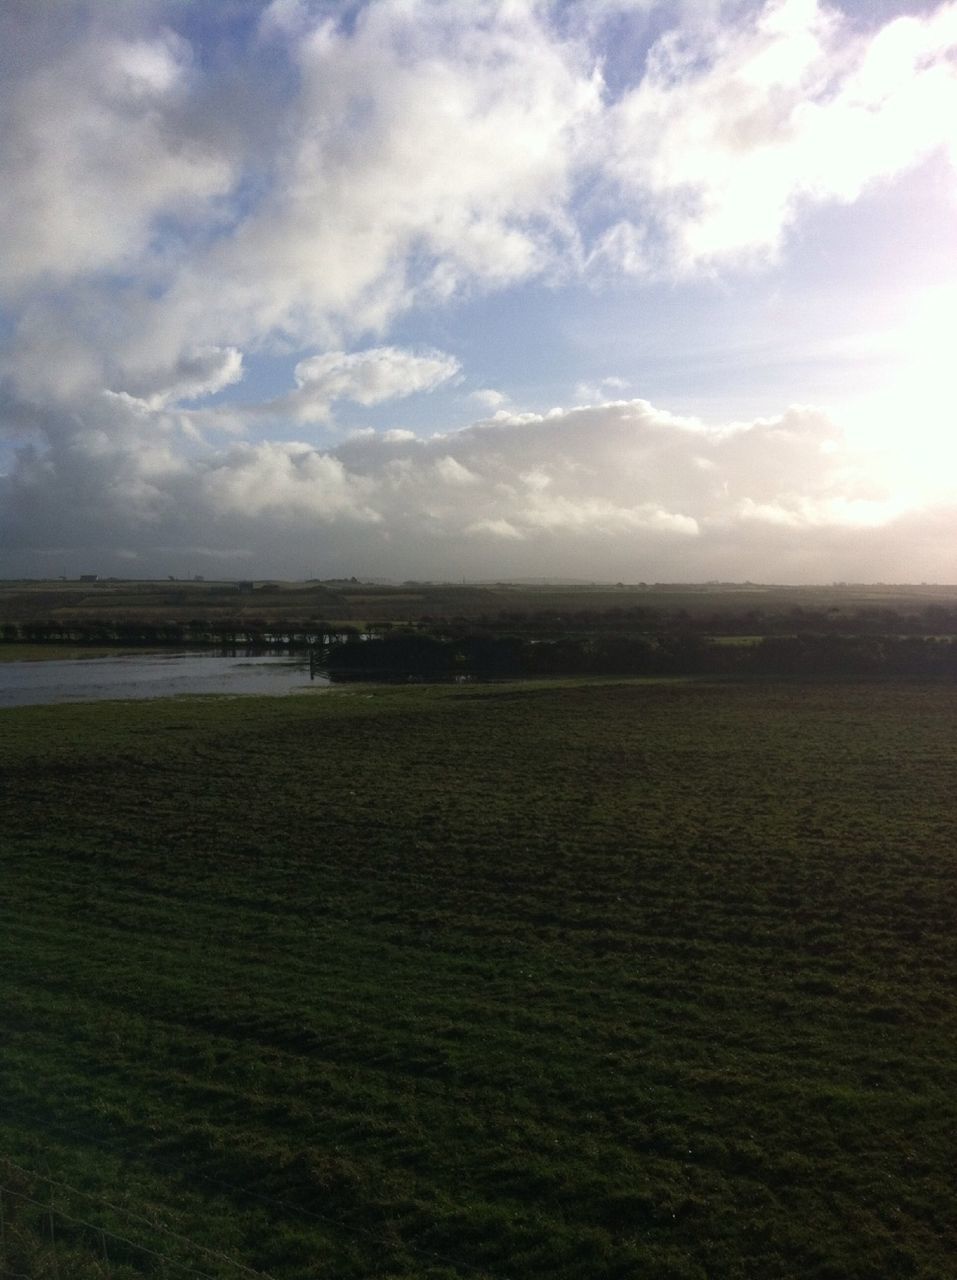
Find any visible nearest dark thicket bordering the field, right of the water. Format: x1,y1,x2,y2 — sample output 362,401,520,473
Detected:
322,630,957,680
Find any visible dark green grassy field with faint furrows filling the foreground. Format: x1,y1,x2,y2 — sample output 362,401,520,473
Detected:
0,682,957,1280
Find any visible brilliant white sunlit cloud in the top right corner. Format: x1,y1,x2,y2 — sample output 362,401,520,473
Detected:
601,0,957,273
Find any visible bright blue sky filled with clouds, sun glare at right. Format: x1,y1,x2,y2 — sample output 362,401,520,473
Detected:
0,0,957,584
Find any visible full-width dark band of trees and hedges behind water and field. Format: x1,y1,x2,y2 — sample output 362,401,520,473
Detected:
0,604,957,680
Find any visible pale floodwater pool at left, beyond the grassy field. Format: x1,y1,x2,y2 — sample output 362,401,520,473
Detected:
0,653,329,707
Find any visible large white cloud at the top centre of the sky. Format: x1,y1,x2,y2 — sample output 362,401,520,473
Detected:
147,0,600,353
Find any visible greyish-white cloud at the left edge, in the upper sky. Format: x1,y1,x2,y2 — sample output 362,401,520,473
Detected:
0,29,237,293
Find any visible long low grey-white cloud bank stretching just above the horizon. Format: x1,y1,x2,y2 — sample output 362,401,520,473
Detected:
0,389,945,580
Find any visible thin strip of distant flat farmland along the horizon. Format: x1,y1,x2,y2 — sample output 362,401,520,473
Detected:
9,575,957,631
